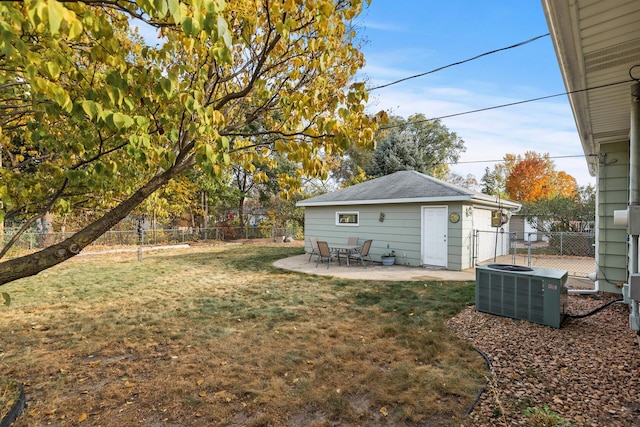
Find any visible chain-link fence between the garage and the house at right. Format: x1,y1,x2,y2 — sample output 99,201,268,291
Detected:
474,230,595,277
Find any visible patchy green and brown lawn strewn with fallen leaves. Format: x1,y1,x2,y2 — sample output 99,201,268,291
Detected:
0,246,487,427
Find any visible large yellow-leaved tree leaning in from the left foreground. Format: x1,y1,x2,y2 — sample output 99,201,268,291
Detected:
0,0,376,285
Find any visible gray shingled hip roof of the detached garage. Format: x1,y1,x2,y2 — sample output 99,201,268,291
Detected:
296,171,520,209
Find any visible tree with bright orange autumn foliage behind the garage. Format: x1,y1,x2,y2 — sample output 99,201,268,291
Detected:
505,151,578,202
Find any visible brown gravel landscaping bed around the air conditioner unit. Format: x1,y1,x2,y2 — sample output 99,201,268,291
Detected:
448,294,640,426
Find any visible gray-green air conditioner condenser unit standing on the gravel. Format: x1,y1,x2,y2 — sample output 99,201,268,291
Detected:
476,264,568,328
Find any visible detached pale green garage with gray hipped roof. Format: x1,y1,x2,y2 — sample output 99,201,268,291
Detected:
297,171,520,270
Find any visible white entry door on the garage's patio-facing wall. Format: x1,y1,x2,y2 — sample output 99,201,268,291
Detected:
422,206,448,268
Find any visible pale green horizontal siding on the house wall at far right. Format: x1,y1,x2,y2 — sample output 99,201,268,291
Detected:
597,142,629,293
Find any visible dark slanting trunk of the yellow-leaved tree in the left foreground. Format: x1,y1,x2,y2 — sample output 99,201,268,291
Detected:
0,161,192,286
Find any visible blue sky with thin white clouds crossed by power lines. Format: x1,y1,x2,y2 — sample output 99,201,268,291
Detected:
356,0,595,185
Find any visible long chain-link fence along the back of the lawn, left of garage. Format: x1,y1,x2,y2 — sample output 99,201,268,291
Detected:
1,226,303,251
